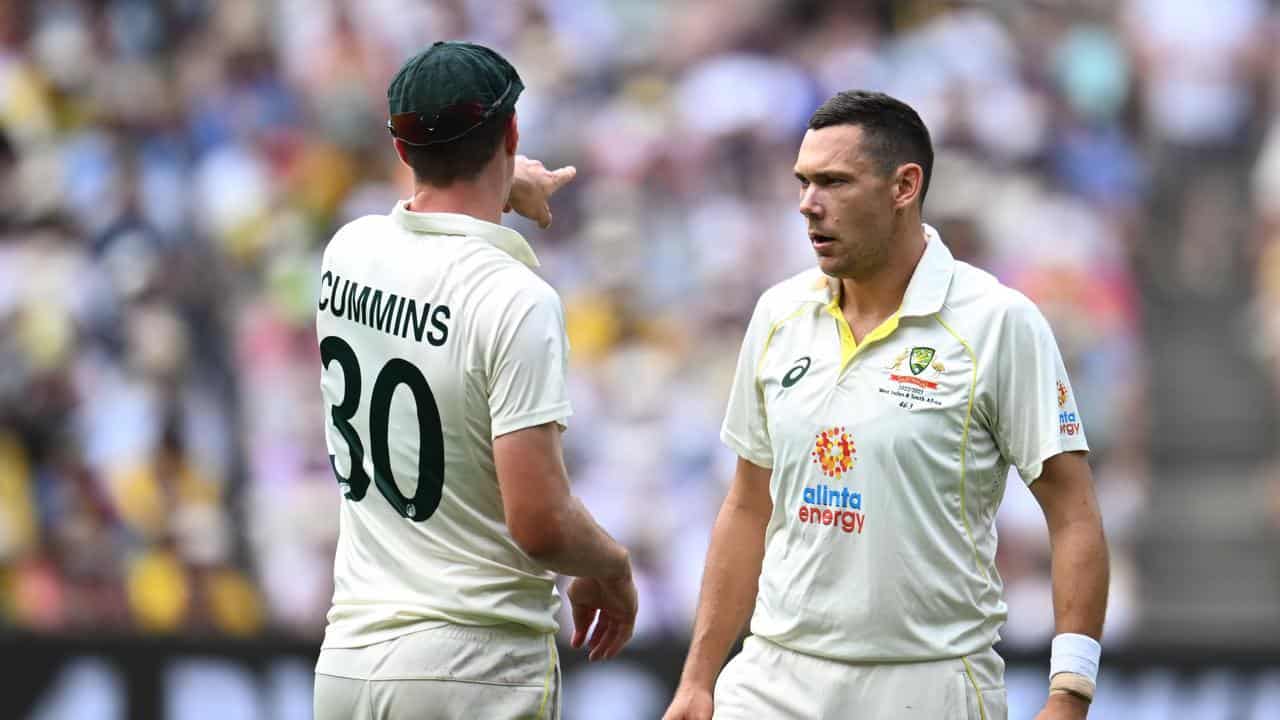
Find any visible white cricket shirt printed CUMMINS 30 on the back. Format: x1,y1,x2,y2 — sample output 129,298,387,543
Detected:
316,202,571,647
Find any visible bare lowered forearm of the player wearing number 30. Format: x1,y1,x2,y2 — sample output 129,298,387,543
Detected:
529,496,631,578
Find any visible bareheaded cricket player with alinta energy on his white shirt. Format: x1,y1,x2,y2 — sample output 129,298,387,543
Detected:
666,92,1108,720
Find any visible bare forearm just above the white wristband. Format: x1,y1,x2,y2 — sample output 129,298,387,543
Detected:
1050,518,1111,639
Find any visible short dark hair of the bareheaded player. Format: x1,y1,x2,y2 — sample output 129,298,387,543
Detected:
809,90,933,205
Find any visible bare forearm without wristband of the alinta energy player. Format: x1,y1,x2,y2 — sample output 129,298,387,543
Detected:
681,503,768,689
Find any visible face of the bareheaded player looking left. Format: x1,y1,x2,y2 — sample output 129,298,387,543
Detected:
795,126,896,279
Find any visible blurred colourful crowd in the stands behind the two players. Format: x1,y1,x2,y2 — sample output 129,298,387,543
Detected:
0,0,1280,712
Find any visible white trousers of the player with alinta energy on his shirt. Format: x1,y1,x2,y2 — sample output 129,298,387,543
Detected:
716,635,1009,720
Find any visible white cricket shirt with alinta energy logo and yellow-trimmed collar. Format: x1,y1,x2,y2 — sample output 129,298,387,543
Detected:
721,225,1088,661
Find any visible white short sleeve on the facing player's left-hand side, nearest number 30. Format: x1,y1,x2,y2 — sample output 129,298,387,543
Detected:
721,299,773,468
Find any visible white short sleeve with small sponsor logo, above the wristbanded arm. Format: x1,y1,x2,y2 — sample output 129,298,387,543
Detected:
996,296,1089,484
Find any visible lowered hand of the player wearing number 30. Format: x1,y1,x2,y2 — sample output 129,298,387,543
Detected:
566,573,639,661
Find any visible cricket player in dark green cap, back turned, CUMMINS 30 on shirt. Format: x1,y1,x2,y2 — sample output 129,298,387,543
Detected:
315,42,636,720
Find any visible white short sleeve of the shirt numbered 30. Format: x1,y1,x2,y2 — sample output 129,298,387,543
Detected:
489,288,573,437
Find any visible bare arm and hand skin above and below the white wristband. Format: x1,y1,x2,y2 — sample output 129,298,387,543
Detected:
1030,452,1111,720
